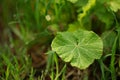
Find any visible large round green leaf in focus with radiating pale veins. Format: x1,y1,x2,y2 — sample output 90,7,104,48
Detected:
51,30,103,69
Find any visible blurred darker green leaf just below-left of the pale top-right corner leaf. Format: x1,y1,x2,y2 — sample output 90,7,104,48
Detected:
93,1,114,30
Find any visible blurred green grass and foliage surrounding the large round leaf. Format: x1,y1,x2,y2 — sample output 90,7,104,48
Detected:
0,0,120,80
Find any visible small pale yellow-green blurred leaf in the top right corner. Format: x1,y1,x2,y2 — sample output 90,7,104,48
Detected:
110,0,120,12
